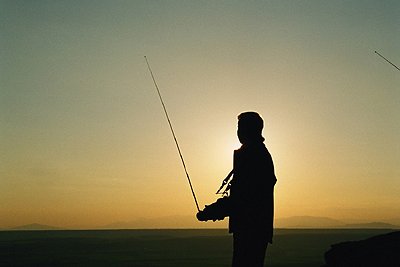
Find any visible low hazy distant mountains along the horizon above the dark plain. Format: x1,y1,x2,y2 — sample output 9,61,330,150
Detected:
5,216,400,231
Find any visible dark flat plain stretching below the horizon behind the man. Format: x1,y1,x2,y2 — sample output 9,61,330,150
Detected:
0,229,391,267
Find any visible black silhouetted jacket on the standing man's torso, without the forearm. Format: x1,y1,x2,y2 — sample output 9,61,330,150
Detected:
229,142,276,243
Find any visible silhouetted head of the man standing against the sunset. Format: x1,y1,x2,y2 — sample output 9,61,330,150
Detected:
237,111,264,144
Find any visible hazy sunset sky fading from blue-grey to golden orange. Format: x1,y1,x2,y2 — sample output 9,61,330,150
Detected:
0,0,400,228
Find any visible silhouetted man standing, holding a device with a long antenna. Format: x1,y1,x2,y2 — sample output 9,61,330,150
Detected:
196,112,277,267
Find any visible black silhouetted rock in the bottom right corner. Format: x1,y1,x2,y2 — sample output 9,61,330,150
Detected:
324,231,400,267
